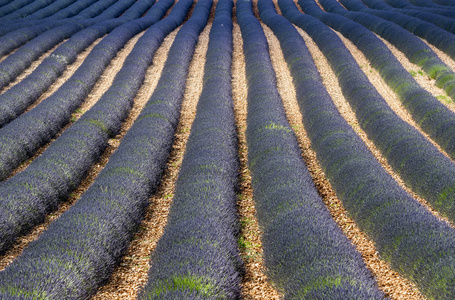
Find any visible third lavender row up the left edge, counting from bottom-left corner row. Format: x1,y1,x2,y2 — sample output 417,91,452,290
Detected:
0,0,175,179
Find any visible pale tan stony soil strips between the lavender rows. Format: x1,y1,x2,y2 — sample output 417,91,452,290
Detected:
0,1,455,299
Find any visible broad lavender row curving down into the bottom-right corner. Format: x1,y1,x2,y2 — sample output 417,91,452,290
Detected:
278,0,455,299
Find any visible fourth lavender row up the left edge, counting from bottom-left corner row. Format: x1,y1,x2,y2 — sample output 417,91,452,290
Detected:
0,1,153,128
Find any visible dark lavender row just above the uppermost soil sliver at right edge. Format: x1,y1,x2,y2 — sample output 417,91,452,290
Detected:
340,0,455,59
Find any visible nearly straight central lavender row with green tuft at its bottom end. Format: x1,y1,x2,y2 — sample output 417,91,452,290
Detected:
139,0,243,299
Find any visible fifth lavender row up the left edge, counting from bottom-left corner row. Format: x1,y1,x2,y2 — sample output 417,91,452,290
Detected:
0,0,141,88
